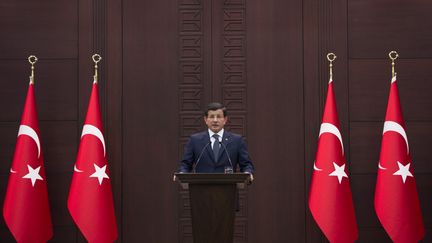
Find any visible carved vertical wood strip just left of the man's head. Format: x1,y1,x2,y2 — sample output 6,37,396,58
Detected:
178,0,207,243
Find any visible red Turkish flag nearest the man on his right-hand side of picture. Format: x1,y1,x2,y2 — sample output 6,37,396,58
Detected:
309,80,358,242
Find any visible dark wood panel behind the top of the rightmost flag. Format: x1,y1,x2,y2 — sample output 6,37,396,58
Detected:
349,59,432,121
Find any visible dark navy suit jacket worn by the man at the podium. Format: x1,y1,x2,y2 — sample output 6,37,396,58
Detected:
178,130,254,173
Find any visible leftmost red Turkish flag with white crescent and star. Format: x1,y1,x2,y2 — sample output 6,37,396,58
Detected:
3,83,53,242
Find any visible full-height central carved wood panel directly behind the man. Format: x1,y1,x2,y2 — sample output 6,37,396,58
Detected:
178,0,247,242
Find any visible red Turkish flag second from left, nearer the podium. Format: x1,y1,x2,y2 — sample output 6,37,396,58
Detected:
68,83,117,243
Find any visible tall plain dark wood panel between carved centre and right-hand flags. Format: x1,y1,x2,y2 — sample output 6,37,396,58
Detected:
246,0,307,242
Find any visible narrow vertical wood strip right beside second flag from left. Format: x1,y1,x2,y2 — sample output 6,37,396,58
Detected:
104,0,123,242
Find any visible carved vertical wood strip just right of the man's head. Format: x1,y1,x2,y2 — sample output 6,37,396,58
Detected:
221,0,248,243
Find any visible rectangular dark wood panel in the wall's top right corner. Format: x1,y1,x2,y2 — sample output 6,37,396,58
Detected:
348,0,432,58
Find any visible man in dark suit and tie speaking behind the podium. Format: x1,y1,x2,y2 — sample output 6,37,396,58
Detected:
178,103,254,180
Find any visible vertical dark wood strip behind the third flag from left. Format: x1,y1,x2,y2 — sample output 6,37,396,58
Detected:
303,0,349,242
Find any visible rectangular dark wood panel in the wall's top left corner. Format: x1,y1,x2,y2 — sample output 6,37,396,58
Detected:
0,0,78,59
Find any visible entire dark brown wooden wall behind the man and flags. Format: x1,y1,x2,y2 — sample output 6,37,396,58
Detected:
0,0,432,243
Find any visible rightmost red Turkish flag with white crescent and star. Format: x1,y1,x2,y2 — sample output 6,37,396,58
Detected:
375,77,425,242
